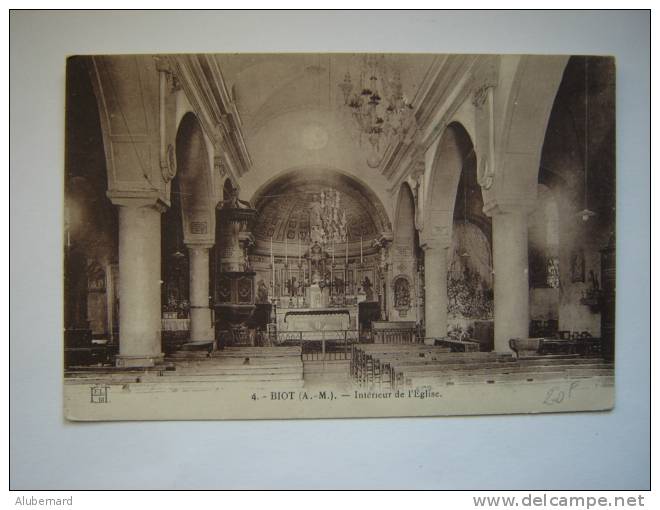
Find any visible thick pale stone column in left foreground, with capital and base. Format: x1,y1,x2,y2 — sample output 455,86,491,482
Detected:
108,192,165,367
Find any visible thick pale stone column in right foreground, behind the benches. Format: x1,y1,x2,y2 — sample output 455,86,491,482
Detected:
484,205,529,352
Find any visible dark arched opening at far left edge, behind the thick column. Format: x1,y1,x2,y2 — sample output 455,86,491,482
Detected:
63,57,118,347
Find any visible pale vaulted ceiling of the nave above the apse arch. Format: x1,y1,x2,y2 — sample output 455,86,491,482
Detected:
215,54,435,209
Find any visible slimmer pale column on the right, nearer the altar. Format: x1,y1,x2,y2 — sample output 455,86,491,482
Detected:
422,243,448,343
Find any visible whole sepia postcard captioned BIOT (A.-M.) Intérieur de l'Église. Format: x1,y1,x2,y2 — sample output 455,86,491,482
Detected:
63,53,616,421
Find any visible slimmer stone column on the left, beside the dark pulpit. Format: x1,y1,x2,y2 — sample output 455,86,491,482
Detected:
186,243,215,346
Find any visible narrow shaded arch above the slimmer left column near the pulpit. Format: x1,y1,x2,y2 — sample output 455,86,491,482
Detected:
174,112,215,242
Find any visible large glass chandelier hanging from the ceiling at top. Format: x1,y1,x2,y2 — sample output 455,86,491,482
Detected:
339,55,415,168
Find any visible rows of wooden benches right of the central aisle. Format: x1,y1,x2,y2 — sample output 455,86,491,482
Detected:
350,344,613,389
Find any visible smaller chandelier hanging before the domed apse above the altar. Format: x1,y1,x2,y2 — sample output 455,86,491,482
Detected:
309,190,347,245
